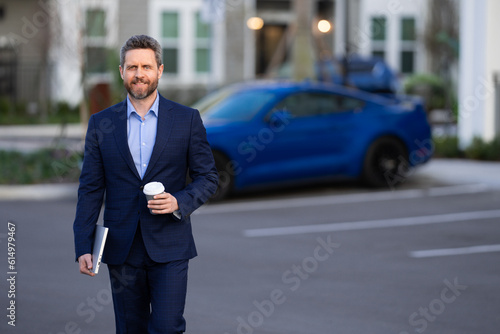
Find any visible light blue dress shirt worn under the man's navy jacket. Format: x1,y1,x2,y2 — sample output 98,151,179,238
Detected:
127,94,160,179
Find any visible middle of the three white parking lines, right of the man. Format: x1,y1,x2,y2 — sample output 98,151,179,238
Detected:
243,210,500,237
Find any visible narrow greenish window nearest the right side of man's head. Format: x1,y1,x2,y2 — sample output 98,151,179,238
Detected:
161,12,179,74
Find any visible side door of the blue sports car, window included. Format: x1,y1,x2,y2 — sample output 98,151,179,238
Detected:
244,91,364,183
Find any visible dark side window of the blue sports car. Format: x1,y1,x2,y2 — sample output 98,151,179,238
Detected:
273,92,364,118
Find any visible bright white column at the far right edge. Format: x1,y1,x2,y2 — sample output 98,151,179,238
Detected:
458,0,500,148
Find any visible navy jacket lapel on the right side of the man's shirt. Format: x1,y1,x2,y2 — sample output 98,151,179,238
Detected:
144,96,173,179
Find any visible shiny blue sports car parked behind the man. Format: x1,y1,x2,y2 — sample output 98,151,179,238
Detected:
194,81,433,200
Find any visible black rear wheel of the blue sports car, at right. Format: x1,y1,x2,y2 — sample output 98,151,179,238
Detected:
363,137,409,188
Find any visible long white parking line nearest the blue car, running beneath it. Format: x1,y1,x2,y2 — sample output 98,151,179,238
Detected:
193,183,491,215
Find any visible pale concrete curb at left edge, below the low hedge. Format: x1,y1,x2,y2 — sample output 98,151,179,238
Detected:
0,183,78,201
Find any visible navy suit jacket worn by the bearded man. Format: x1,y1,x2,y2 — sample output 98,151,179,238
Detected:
73,96,218,264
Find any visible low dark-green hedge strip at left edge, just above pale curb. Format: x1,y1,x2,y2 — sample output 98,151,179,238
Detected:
0,149,82,184
